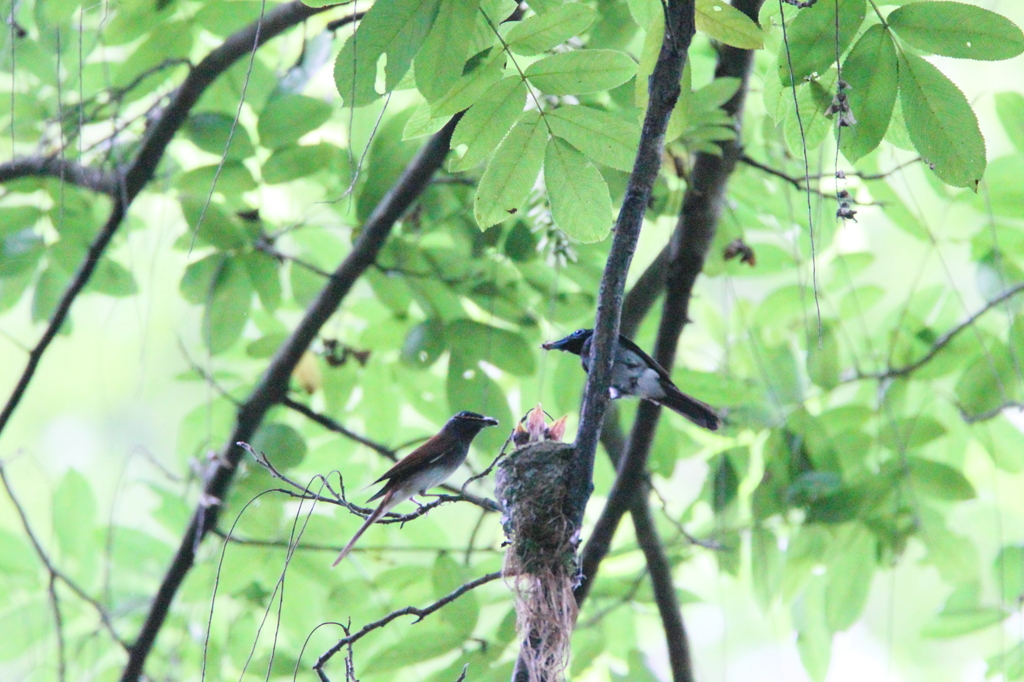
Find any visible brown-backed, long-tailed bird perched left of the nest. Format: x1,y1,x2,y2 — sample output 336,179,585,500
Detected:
331,412,498,566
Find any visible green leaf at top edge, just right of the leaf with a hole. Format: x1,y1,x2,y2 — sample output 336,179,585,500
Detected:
415,0,479,101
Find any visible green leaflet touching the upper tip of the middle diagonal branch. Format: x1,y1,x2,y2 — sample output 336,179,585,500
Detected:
450,76,526,172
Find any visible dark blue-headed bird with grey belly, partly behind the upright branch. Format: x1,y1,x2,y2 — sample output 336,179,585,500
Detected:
541,329,722,431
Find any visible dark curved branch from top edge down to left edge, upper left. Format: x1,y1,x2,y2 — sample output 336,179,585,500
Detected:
0,2,326,450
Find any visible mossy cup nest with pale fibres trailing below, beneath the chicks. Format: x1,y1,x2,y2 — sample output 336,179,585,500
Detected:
496,440,580,682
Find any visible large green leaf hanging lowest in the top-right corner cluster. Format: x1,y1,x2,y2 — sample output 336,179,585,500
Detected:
899,52,985,189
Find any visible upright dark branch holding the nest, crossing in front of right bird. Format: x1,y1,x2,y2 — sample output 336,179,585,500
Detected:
566,0,694,521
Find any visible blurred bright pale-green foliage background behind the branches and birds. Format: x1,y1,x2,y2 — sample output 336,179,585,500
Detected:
0,1,1024,680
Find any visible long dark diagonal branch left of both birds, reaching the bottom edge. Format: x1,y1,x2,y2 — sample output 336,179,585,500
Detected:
121,116,460,682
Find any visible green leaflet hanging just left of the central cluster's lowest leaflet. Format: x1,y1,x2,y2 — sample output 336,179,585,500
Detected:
473,111,548,229
